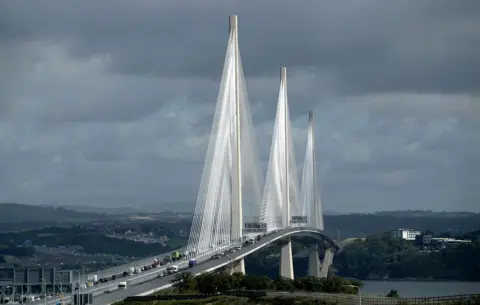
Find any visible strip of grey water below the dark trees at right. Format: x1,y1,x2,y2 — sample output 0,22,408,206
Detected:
362,281,480,297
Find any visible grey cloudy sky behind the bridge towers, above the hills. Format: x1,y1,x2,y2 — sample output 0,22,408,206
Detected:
0,0,480,213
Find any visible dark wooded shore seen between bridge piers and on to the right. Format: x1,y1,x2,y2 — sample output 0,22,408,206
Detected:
245,231,480,281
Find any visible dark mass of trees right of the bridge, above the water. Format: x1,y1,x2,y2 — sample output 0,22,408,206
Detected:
334,234,480,281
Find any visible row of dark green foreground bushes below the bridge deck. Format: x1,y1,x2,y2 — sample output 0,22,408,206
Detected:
172,272,362,295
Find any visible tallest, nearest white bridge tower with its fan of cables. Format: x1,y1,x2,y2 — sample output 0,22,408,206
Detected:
187,16,262,256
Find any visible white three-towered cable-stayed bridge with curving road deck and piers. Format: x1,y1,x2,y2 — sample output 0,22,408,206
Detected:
28,16,341,304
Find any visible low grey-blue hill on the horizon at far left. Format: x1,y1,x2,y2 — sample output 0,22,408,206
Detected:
0,203,105,223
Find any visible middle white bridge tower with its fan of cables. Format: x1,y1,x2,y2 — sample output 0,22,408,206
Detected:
260,67,300,231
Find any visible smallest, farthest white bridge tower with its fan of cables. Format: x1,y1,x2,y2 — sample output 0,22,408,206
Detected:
300,111,324,230
